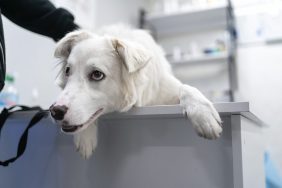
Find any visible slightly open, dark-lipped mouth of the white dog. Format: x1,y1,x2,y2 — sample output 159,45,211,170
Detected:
61,108,103,133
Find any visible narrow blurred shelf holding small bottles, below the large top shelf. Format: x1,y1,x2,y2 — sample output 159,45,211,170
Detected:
170,53,228,66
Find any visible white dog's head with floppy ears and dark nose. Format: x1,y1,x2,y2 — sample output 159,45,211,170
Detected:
50,31,151,133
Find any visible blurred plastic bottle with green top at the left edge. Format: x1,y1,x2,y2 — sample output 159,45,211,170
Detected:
0,74,19,107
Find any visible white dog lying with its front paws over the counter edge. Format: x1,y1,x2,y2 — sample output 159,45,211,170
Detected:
50,25,222,158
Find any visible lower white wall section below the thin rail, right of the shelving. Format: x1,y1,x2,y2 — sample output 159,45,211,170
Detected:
237,45,282,169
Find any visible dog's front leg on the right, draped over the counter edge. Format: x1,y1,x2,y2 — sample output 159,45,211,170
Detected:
179,85,222,139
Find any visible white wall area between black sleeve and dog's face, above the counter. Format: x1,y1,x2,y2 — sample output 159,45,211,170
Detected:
3,16,58,108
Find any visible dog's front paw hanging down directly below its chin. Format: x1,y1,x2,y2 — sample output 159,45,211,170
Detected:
74,124,97,159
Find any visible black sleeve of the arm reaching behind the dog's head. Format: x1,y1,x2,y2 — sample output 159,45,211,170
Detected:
0,0,78,41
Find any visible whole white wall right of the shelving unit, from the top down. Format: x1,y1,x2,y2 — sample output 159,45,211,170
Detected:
234,0,282,170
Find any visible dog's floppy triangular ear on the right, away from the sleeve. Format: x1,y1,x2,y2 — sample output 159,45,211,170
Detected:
112,39,152,73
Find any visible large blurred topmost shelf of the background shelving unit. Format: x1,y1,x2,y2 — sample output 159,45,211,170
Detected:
146,4,228,37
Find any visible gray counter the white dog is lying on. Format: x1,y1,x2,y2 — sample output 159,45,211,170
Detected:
0,102,265,188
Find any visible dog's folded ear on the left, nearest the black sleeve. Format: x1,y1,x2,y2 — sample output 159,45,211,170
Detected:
54,30,91,59
